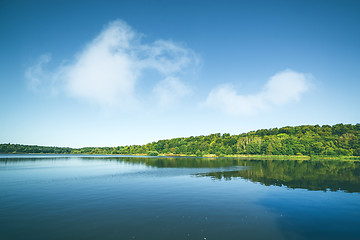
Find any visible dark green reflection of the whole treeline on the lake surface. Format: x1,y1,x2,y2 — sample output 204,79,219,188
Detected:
0,156,360,192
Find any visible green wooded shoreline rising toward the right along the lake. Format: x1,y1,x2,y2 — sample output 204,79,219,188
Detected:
0,124,360,156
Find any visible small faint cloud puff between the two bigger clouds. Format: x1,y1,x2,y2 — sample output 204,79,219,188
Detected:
153,77,191,106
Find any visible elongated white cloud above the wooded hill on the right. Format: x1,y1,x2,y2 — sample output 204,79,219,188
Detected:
205,69,312,115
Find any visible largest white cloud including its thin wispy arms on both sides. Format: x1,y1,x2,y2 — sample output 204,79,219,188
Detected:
25,20,198,106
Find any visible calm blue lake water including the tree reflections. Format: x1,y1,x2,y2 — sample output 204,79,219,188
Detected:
0,155,360,240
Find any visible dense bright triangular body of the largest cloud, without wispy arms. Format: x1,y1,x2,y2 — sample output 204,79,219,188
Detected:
63,22,139,105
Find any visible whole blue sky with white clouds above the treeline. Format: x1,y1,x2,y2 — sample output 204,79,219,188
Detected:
0,0,360,147
